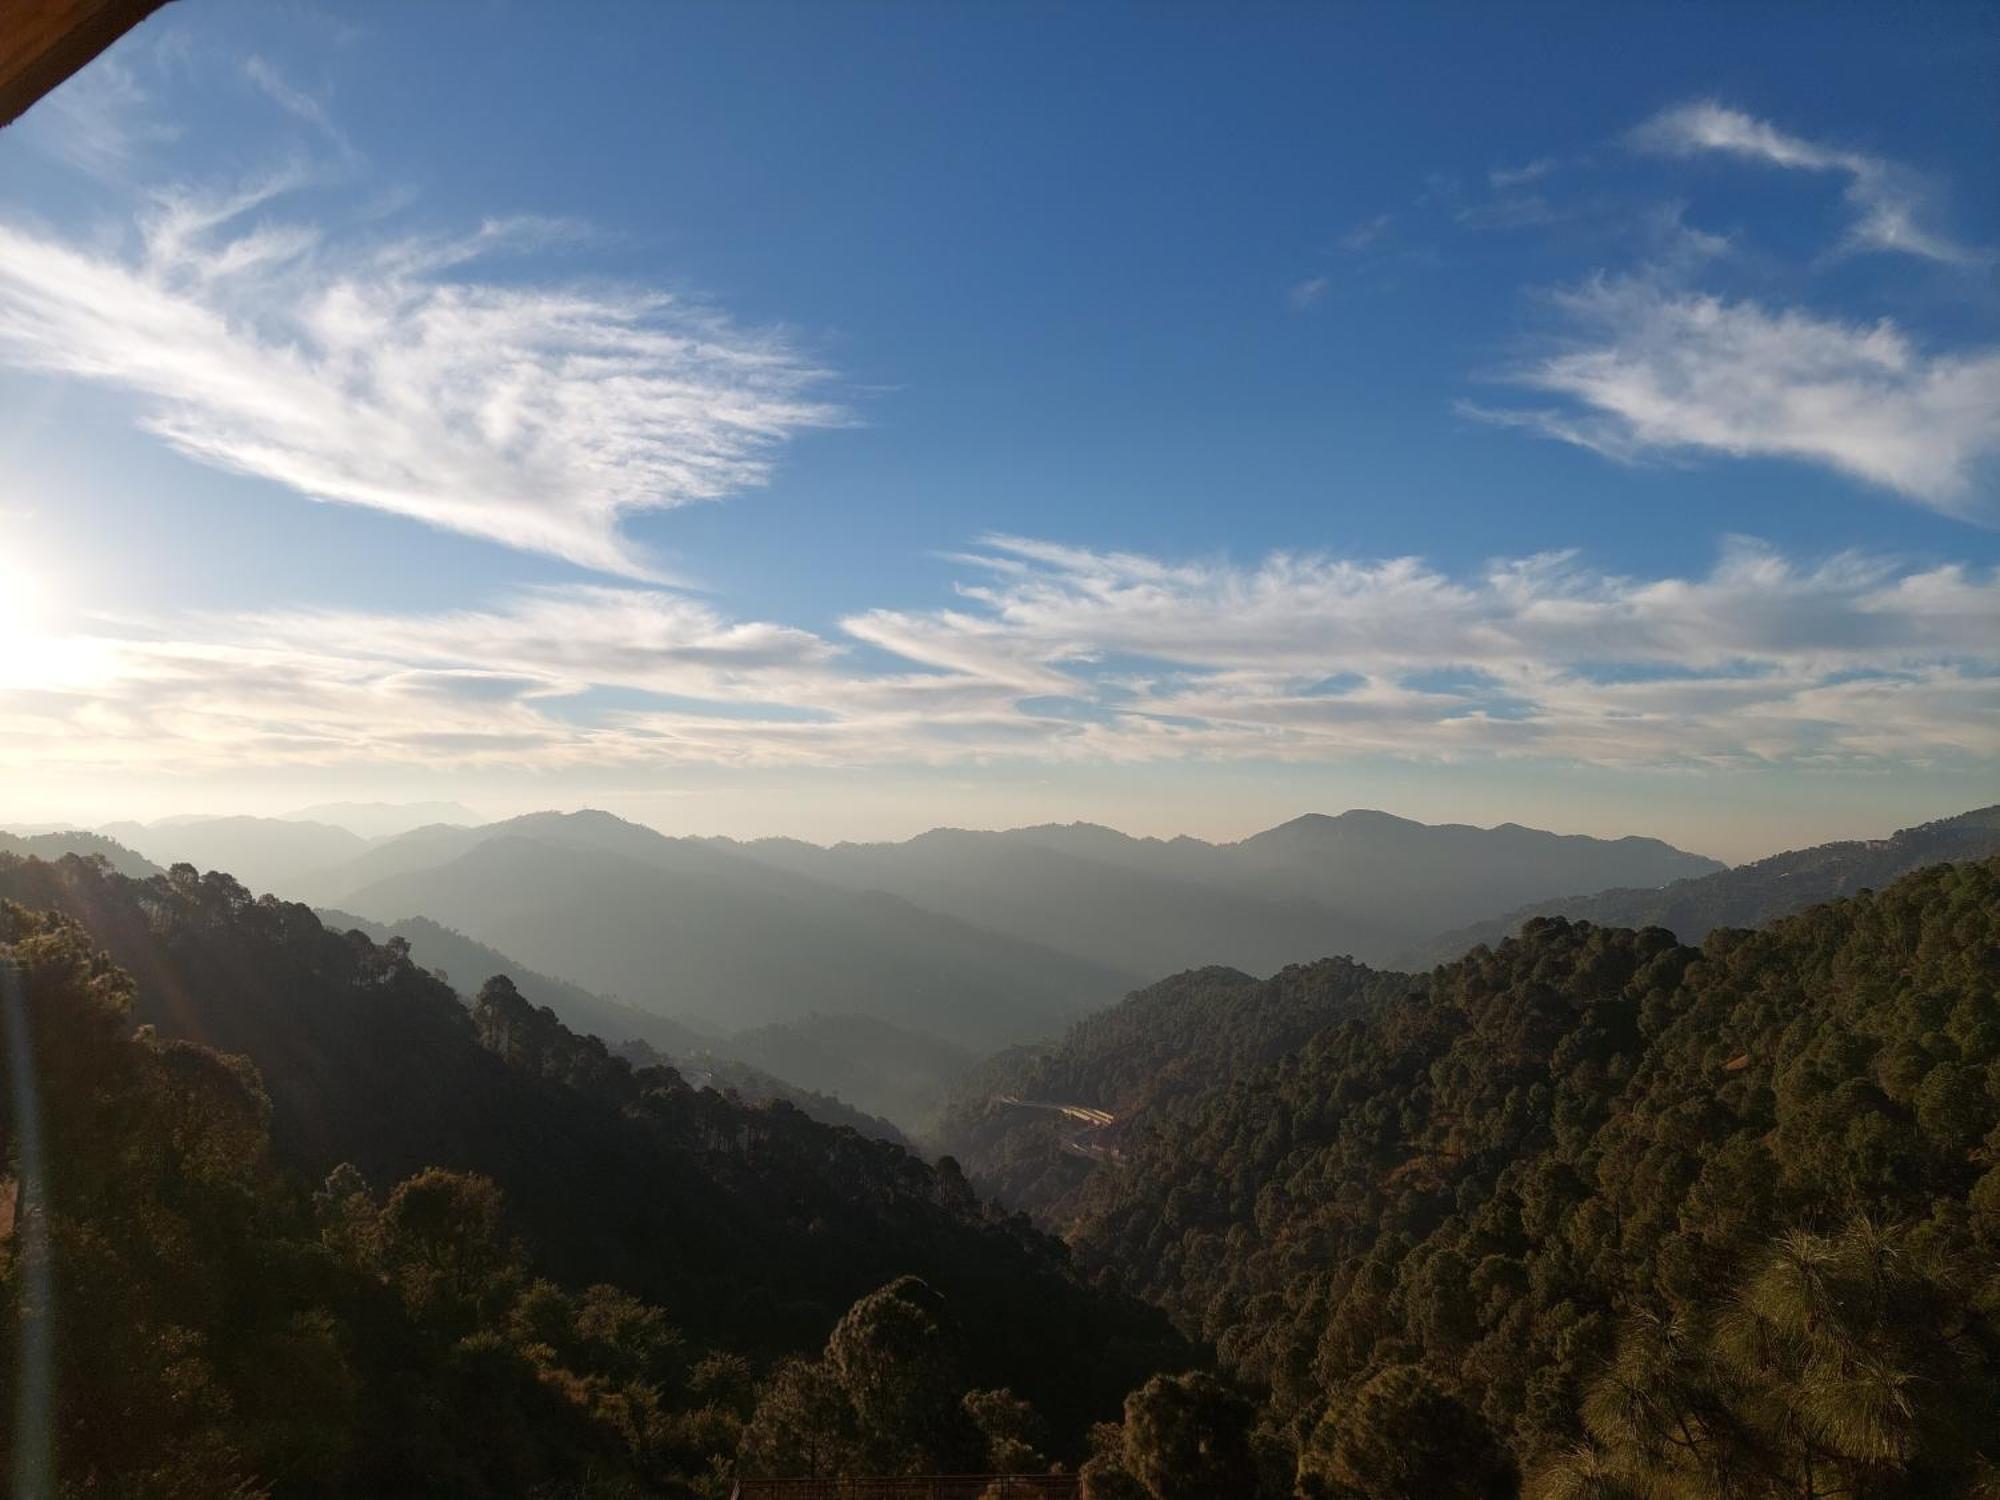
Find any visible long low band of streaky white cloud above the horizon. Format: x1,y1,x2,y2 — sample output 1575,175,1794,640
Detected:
0,538,2000,770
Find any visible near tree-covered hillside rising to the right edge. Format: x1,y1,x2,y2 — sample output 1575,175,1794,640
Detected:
1068,860,2000,1500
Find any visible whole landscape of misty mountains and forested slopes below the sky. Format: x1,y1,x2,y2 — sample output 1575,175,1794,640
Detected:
0,808,2000,1496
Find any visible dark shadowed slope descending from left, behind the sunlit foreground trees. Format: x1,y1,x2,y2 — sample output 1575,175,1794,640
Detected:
0,856,1186,1434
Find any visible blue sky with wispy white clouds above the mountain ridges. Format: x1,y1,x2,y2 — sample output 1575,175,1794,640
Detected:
0,0,2000,860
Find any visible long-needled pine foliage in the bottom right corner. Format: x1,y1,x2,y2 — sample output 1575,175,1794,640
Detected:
1534,1220,2000,1498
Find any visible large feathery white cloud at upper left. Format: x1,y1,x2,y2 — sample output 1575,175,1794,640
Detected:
0,170,840,576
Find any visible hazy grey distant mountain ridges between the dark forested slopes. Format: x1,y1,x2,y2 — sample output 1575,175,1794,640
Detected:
62,812,1720,1086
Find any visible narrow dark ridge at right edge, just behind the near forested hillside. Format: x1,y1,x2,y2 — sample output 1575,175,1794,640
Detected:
1398,806,2000,968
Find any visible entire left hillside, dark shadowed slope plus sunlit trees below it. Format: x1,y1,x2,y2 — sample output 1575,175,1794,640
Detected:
0,856,1188,1496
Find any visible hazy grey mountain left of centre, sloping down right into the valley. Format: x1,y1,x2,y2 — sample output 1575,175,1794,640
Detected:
344,814,1130,1046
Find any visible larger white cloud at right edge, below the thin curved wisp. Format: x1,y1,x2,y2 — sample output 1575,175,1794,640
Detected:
1466,278,2000,518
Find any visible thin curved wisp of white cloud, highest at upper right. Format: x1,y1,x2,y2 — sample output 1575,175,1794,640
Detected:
1632,100,1992,264
